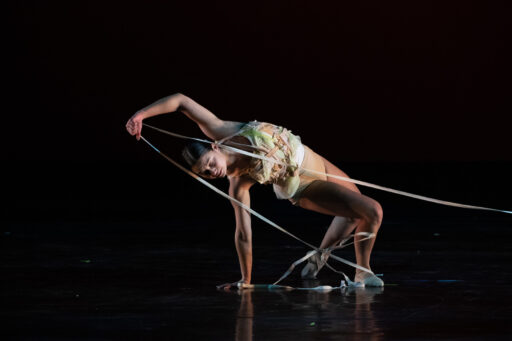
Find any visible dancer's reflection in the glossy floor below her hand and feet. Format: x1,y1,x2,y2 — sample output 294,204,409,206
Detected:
228,288,384,341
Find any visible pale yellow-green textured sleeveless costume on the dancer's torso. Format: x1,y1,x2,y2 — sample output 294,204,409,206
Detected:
218,121,327,205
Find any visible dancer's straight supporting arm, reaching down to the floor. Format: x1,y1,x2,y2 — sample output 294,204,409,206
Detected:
225,177,254,284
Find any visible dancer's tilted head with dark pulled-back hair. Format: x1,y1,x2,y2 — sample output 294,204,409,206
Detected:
182,142,227,179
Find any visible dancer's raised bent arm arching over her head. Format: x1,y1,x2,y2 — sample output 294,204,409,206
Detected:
126,93,242,140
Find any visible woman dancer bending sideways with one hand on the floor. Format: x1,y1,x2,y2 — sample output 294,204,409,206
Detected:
126,93,384,288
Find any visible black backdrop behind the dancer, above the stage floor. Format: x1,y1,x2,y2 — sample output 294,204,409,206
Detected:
2,1,512,221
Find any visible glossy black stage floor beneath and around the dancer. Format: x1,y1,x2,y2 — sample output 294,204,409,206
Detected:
0,222,512,340
